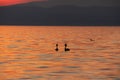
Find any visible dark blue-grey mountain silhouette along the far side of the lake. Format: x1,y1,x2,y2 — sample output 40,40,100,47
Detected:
0,3,120,26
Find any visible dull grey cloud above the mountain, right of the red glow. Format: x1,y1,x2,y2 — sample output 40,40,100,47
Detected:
45,0,120,6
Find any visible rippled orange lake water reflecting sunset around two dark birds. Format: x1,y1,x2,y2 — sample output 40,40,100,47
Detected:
0,26,120,80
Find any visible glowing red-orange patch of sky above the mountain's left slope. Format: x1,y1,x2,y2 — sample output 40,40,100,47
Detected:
0,0,46,6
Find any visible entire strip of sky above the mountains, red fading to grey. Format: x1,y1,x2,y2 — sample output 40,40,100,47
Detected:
0,0,120,6
